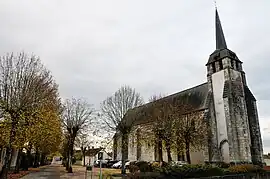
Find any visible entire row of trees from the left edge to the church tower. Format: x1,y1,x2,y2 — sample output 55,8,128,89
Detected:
0,53,208,178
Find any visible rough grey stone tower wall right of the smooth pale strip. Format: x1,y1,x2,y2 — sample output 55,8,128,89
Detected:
223,69,251,162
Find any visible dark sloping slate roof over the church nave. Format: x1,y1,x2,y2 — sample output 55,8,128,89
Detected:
123,83,209,125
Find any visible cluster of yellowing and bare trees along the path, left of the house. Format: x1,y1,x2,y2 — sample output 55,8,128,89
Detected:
0,53,95,176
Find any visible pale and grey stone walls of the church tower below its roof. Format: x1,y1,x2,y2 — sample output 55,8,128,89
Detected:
208,57,253,162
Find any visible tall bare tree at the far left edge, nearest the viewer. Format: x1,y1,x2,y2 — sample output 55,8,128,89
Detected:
0,53,57,179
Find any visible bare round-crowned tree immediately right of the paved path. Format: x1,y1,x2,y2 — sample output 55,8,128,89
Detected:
62,99,94,173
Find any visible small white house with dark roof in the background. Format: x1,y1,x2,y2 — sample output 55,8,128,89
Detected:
82,147,112,165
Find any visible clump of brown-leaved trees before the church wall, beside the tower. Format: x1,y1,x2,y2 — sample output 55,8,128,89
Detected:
148,96,208,163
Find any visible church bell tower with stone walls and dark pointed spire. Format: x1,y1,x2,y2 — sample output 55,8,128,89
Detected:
206,9,262,163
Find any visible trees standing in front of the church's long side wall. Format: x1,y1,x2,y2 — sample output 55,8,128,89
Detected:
101,86,208,173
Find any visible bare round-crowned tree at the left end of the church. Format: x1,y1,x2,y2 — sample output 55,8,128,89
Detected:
101,86,143,173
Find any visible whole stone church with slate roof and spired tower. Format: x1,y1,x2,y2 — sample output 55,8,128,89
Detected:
113,10,263,163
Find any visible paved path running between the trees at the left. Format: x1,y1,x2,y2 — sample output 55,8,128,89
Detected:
22,165,61,179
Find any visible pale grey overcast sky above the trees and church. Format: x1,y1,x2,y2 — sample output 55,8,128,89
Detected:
0,0,270,153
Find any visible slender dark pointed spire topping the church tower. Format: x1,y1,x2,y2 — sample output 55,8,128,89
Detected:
216,8,227,50
